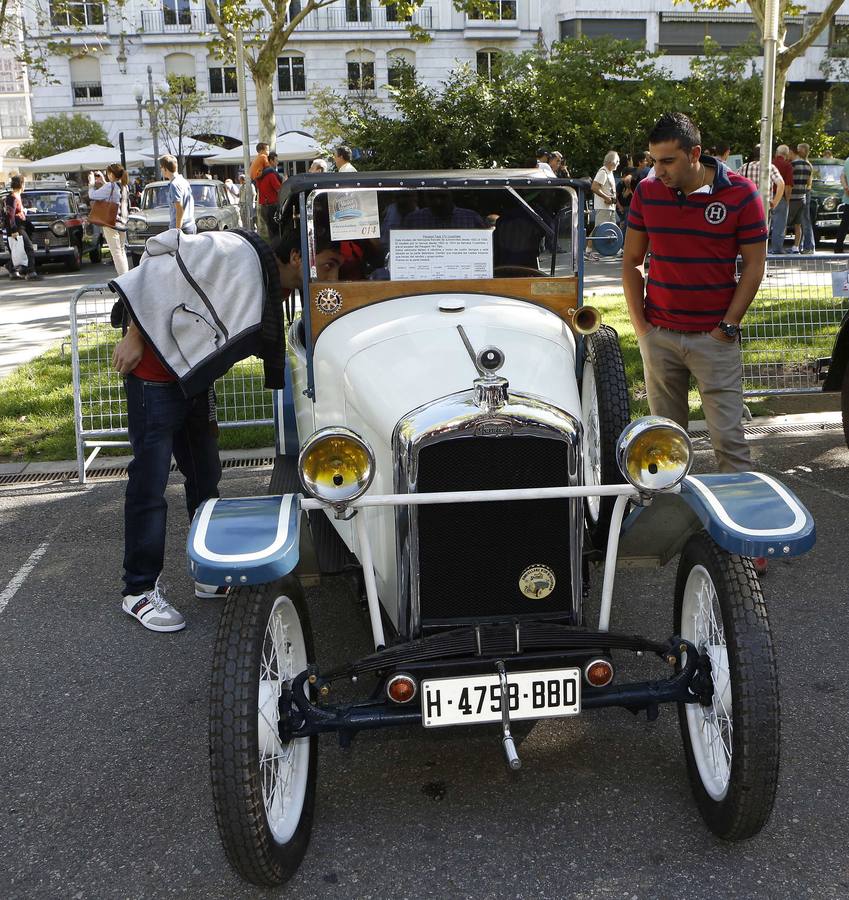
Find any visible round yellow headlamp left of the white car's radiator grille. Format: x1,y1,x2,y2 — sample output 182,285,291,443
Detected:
298,427,374,504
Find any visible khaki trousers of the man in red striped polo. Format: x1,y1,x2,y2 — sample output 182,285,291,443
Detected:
638,326,752,472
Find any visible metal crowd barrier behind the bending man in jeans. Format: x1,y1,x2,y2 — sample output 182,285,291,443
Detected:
71,284,274,484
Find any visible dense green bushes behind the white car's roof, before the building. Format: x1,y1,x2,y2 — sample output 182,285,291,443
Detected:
306,38,761,175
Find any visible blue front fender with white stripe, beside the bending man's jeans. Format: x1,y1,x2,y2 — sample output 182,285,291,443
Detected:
186,494,301,587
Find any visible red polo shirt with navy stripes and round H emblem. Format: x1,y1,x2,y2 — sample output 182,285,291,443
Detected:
628,156,767,331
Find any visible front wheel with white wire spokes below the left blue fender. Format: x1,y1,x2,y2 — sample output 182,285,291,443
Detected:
209,575,318,886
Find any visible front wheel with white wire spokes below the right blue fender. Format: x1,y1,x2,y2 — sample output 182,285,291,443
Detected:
674,531,780,841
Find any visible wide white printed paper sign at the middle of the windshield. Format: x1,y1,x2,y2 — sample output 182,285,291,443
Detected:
389,228,492,281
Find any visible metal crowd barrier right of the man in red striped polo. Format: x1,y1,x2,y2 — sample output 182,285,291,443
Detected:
742,254,849,397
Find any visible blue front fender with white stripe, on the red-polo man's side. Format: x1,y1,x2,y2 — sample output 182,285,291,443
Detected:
619,472,816,565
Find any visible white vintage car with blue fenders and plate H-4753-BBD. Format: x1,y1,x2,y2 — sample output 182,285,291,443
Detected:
188,170,814,884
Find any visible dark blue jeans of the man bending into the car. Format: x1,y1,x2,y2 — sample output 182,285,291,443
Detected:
124,375,221,596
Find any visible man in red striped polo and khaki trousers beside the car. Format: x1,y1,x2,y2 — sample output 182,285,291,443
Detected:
622,113,767,472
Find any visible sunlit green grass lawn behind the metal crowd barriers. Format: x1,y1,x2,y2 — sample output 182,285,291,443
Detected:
0,286,843,462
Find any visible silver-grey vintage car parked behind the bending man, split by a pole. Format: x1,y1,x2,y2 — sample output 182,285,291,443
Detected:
127,178,239,265
